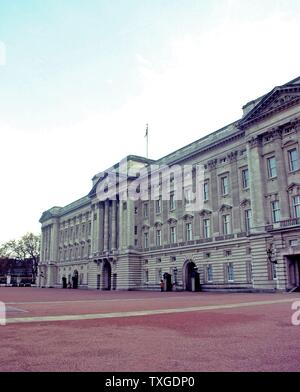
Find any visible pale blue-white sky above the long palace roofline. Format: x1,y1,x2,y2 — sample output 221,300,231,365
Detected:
0,0,300,243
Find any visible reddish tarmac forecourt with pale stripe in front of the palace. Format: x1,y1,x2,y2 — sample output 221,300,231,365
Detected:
0,287,300,372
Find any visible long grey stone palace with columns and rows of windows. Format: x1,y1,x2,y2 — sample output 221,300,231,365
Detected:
38,77,300,291
